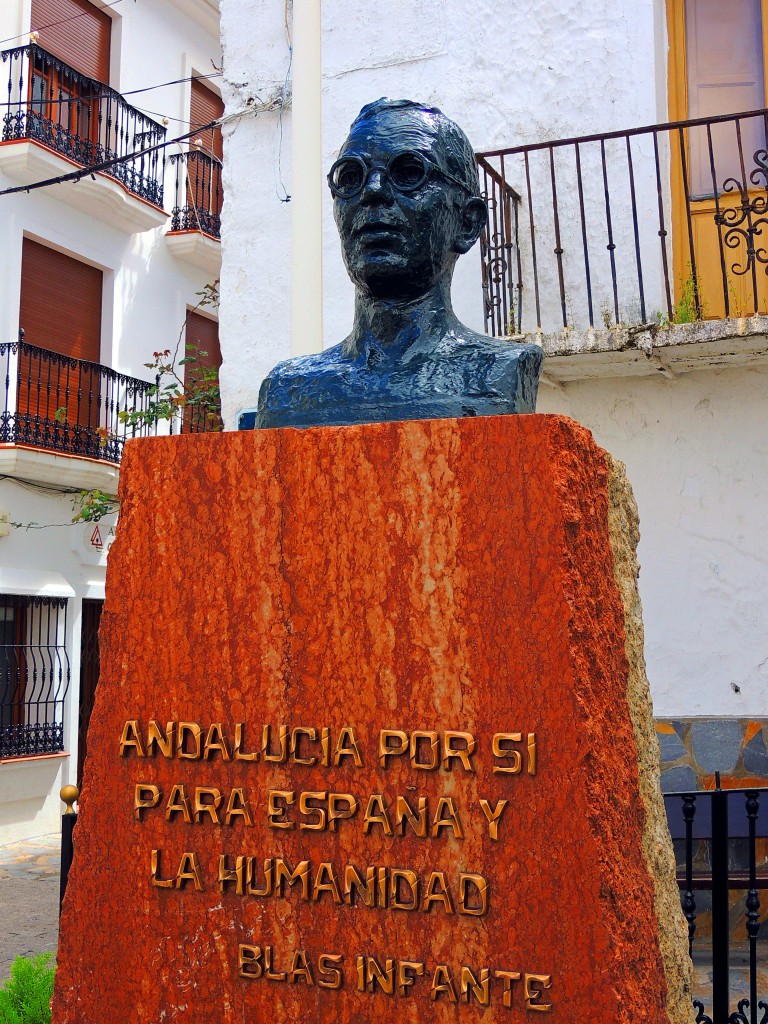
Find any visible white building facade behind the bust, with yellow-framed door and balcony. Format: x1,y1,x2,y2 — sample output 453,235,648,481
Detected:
221,0,768,791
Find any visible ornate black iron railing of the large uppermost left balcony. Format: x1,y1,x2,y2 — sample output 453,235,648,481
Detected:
1,43,166,208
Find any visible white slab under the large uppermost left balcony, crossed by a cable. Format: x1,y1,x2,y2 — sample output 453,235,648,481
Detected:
0,139,168,234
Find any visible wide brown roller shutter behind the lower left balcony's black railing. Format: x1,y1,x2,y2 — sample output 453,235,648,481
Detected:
18,239,102,428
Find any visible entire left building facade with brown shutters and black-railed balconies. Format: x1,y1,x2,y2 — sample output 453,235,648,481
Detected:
0,0,222,844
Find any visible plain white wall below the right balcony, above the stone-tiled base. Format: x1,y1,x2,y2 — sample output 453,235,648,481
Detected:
538,366,768,718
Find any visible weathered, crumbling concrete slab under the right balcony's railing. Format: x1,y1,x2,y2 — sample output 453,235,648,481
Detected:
528,316,768,385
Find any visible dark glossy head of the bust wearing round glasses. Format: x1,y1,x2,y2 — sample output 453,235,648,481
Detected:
328,99,486,300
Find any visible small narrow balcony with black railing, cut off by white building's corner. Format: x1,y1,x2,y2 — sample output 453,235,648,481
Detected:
166,150,223,276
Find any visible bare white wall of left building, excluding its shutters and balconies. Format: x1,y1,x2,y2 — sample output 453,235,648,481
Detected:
0,0,221,844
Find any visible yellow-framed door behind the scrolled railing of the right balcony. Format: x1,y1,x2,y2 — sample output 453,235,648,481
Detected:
668,0,768,319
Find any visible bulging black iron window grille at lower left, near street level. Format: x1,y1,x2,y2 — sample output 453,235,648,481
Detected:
0,594,70,759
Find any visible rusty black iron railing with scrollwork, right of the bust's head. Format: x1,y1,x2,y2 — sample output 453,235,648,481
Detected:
477,110,768,334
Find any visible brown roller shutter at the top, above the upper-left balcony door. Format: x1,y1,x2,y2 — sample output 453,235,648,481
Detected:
32,0,112,85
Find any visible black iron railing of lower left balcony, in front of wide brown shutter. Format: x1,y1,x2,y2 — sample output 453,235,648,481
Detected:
0,341,155,463
